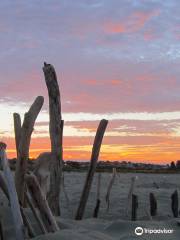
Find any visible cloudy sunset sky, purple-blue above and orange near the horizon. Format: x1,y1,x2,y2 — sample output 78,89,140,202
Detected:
0,0,180,164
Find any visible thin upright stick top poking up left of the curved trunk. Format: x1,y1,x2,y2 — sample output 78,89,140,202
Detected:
13,113,21,156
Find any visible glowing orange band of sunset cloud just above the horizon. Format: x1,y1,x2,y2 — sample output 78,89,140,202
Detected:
4,133,180,163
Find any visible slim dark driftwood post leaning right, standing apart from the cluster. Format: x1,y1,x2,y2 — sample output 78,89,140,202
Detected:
75,119,108,220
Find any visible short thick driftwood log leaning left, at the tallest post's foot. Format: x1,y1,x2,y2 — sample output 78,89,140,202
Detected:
26,174,59,232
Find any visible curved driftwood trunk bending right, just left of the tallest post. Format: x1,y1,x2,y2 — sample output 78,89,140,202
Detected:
15,96,44,205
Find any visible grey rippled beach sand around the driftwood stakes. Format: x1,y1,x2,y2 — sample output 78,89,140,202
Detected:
0,172,180,240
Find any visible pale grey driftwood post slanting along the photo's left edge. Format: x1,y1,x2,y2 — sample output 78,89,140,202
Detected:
0,143,25,240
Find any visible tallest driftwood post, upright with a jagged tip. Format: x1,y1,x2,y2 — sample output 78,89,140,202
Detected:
43,63,64,216
